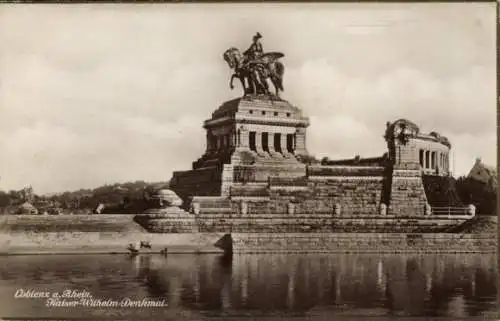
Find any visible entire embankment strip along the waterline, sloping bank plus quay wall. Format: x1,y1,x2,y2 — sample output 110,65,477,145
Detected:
0,215,497,254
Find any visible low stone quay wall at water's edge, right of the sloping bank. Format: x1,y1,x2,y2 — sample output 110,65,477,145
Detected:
231,233,498,253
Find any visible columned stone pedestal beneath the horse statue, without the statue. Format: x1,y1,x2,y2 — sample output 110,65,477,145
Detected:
170,96,309,203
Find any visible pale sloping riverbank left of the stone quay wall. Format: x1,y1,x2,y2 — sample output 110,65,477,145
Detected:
0,215,224,255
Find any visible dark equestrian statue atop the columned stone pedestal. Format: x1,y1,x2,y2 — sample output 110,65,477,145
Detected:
223,32,285,97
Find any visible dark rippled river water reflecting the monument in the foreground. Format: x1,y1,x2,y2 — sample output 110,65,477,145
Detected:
0,254,498,320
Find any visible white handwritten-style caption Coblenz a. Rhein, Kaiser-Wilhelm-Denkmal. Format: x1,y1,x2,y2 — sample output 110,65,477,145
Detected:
14,289,167,308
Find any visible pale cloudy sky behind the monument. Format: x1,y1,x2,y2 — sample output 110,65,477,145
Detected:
0,3,497,194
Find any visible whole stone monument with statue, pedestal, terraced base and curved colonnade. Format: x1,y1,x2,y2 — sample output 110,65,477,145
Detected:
152,33,470,233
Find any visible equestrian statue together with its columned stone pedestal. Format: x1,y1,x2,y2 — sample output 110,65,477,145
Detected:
170,33,309,201
